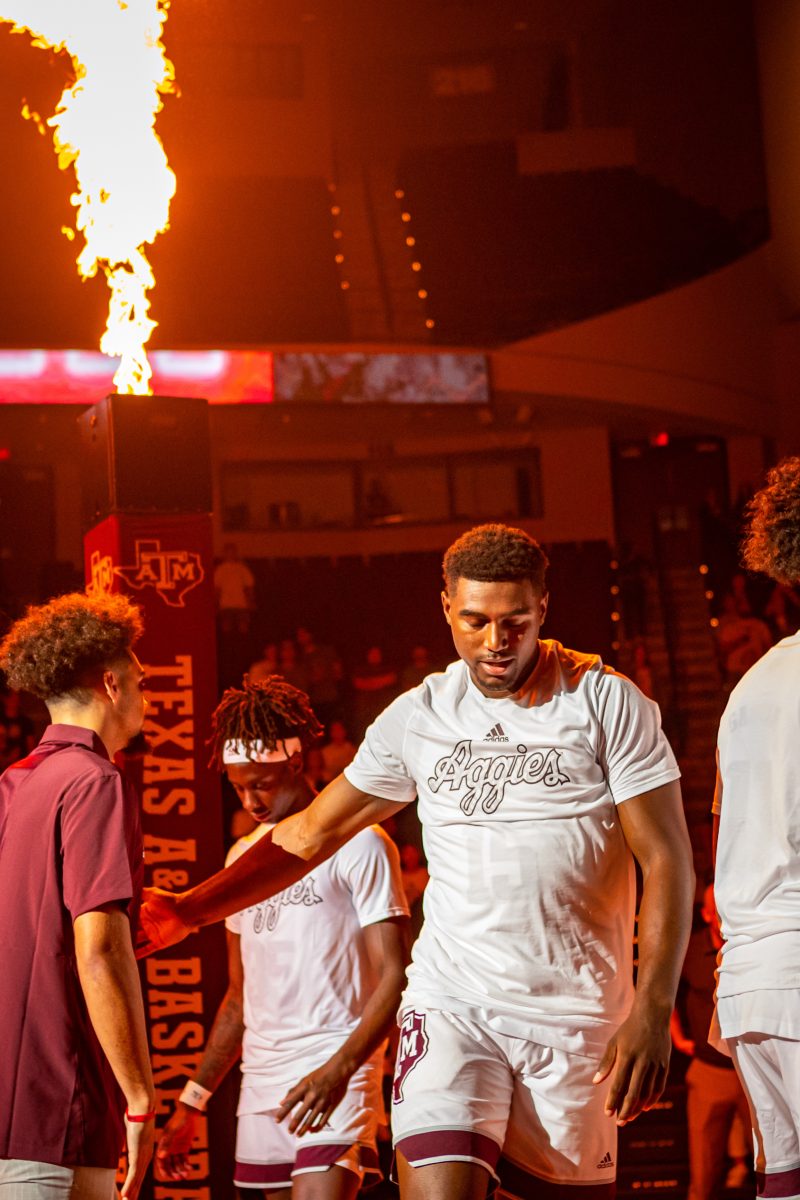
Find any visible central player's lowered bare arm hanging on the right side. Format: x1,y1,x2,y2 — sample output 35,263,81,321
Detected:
595,781,694,1124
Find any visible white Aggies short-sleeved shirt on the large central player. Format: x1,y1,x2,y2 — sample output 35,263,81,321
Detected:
344,641,679,1054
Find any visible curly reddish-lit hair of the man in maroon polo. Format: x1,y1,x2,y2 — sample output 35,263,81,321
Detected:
0,592,144,700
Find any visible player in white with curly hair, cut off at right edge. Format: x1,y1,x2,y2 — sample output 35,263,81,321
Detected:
711,458,800,1200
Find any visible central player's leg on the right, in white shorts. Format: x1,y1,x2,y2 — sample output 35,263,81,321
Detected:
498,1038,616,1200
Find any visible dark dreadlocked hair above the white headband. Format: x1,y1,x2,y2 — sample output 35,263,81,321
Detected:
209,676,323,770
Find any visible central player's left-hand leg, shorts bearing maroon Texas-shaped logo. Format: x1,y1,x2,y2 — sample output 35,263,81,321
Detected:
392,1010,513,1200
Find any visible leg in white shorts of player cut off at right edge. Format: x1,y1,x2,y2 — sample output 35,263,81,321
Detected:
728,1033,800,1200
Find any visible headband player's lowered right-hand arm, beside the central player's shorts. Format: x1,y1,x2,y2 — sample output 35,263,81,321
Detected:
277,917,408,1136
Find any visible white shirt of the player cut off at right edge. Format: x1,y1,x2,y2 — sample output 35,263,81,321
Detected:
714,634,800,1038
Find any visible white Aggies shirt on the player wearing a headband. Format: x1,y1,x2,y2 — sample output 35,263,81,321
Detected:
225,826,408,1089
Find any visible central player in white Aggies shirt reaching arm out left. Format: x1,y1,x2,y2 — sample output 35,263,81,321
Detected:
144,526,693,1200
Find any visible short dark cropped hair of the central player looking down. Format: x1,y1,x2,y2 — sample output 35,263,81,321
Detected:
441,524,548,595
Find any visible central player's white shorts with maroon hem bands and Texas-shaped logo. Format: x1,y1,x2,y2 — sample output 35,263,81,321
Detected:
392,1009,616,1200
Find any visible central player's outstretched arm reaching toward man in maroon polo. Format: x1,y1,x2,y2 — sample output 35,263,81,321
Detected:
137,775,407,958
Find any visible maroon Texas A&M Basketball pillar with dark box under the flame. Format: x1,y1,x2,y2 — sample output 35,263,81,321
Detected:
79,395,234,1200
